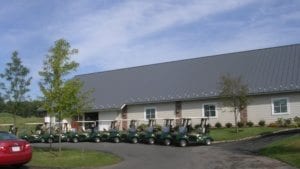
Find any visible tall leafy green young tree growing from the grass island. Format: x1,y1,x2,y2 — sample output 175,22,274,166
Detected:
39,39,92,150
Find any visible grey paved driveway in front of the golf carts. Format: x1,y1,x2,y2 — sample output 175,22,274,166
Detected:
28,133,298,169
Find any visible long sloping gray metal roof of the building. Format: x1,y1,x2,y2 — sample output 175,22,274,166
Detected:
76,44,300,109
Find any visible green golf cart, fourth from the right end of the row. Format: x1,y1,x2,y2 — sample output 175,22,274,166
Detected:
121,120,139,144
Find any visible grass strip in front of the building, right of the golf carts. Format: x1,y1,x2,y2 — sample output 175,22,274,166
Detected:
210,127,282,141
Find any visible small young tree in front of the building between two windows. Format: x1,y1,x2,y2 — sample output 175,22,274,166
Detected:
219,75,249,133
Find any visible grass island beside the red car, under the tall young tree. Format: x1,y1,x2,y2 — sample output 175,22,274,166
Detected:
27,148,121,168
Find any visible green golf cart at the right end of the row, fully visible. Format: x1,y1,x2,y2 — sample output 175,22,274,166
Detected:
173,118,213,147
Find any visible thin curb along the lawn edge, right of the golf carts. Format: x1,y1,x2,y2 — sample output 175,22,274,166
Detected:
213,128,300,144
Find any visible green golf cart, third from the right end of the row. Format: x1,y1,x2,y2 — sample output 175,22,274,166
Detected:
140,119,156,144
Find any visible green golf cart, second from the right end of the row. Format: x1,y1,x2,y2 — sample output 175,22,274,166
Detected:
156,119,174,146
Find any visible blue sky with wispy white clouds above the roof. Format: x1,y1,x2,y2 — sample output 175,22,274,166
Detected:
0,0,300,99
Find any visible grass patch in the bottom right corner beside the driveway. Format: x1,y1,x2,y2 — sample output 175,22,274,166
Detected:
260,134,300,168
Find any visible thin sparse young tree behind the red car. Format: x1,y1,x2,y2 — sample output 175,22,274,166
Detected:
0,51,32,126
